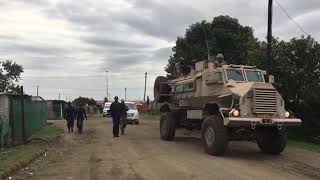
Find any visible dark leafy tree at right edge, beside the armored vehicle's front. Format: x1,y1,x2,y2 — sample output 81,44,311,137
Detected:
272,36,320,136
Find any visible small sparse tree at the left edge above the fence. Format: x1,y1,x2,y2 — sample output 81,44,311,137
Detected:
0,60,23,94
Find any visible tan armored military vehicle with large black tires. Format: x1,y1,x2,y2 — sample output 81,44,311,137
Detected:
154,58,301,155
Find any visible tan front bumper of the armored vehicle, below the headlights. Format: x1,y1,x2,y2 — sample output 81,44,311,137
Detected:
224,117,302,127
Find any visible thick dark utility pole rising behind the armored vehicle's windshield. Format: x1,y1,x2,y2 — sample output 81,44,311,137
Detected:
267,0,273,75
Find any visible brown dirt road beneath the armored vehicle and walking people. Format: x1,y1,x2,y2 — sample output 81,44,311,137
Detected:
16,118,320,180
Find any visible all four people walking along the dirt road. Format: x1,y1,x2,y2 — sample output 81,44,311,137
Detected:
64,96,129,137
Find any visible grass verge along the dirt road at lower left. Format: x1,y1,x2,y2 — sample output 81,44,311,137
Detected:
0,125,63,179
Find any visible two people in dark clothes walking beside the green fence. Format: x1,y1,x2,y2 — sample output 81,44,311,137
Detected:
64,103,88,134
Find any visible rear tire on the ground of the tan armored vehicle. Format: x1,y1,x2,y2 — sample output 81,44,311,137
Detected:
160,112,176,141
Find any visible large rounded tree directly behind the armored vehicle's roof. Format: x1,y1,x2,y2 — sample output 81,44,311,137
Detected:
165,16,260,77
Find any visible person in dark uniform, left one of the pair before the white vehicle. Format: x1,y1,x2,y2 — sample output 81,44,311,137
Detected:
110,96,121,137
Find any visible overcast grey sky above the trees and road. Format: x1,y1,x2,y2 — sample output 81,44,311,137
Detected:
0,0,320,99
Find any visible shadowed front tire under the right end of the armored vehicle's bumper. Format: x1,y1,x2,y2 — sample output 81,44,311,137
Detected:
257,128,287,155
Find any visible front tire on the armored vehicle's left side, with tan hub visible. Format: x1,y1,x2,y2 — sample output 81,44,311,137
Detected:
201,115,228,156
